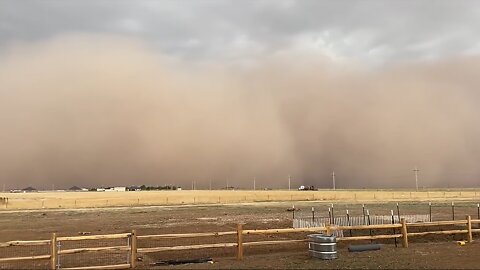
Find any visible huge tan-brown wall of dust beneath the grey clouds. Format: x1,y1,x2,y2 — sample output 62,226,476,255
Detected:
0,34,480,188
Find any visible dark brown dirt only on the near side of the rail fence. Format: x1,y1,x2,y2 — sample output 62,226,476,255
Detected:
152,241,480,269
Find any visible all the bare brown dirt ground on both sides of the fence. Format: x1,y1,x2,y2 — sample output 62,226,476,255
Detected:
0,202,480,269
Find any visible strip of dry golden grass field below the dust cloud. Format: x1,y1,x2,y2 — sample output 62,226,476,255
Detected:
0,189,480,210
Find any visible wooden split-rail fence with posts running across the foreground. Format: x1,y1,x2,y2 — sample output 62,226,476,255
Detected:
0,216,480,270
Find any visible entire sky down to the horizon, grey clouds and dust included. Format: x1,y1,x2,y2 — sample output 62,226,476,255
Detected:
0,0,480,188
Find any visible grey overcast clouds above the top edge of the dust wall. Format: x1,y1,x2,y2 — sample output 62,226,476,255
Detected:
0,0,480,66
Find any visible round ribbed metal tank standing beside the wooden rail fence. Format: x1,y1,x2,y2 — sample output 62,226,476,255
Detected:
308,234,337,260
